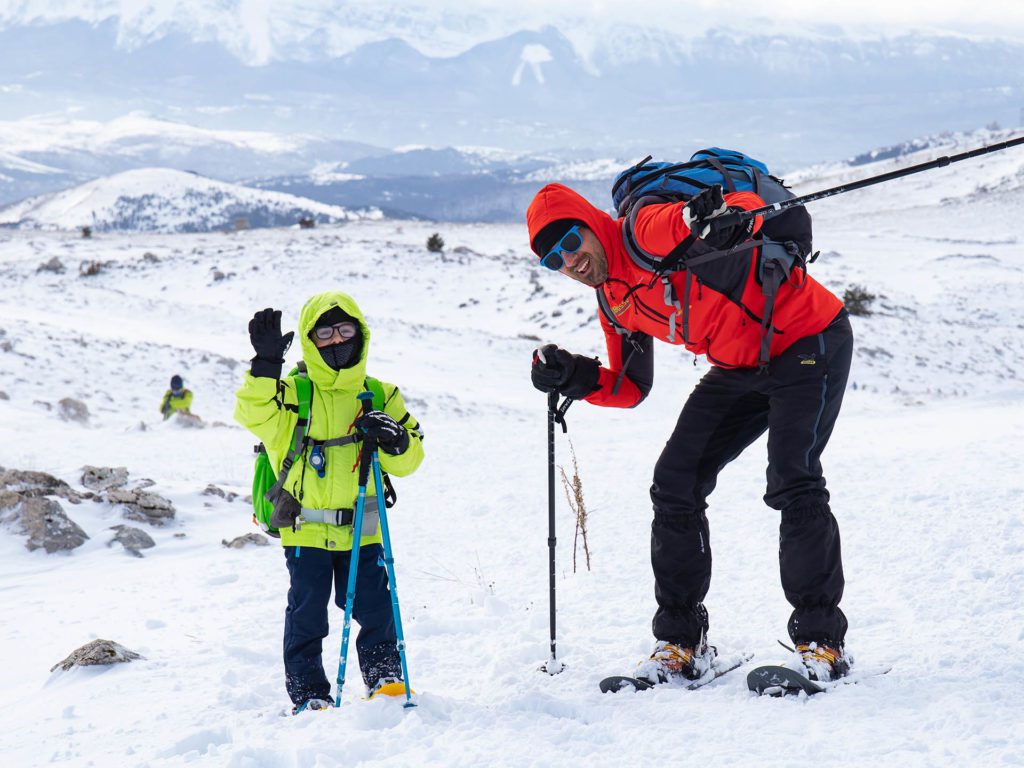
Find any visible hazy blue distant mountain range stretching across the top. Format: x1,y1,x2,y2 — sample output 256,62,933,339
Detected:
0,12,1024,165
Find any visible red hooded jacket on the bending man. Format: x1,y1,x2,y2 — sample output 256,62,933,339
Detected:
526,184,843,408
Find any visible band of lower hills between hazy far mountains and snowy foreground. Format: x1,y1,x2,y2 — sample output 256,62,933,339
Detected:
0,130,1024,231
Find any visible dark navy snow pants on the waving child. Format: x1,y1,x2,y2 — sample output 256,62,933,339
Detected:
285,544,401,705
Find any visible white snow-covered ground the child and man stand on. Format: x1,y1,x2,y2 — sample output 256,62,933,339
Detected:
0,151,1024,768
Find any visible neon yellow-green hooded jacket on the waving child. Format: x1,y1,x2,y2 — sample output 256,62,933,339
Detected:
234,291,423,551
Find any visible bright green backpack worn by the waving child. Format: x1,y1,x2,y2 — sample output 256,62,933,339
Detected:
252,362,387,539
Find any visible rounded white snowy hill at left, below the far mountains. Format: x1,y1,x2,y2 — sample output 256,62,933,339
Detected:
0,168,380,232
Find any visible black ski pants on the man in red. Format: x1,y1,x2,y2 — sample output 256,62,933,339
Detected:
650,310,853,646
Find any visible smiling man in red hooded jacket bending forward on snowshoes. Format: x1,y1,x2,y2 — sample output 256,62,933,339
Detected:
526,184,853,683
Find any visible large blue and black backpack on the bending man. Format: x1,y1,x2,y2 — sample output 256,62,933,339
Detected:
598,146,817,372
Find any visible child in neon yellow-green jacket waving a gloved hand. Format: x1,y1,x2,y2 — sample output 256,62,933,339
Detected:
234,291,423,714
